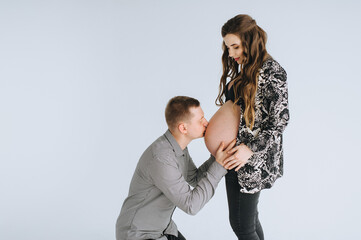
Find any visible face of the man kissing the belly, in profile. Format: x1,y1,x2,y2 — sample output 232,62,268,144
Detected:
186,107,208,140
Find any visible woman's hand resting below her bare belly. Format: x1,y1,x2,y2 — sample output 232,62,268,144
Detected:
223,143,253,171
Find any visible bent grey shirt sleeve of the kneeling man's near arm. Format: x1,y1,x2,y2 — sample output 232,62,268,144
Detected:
149,154,227,215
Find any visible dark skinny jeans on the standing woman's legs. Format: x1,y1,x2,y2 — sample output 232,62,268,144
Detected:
226,169,264,240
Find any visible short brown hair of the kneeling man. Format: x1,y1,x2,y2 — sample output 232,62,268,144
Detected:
165,96,200,129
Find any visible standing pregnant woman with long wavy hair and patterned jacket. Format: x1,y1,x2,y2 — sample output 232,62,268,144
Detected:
205,15,289,240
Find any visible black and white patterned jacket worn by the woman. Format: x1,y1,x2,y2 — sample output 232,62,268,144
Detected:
232,59,289,193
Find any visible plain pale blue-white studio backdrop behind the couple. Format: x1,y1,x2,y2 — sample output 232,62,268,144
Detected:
0,0,361,240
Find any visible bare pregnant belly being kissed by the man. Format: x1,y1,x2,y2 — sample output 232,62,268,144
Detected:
204,100,240,156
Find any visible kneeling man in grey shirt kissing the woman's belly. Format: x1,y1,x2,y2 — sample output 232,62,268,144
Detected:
116,96,235,240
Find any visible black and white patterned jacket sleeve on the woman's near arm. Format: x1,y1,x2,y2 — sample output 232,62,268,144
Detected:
247,62,289,162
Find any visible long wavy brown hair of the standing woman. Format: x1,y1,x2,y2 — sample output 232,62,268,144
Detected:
216,14,270,129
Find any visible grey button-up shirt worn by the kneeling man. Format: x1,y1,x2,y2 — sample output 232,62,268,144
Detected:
116,130,227,240
